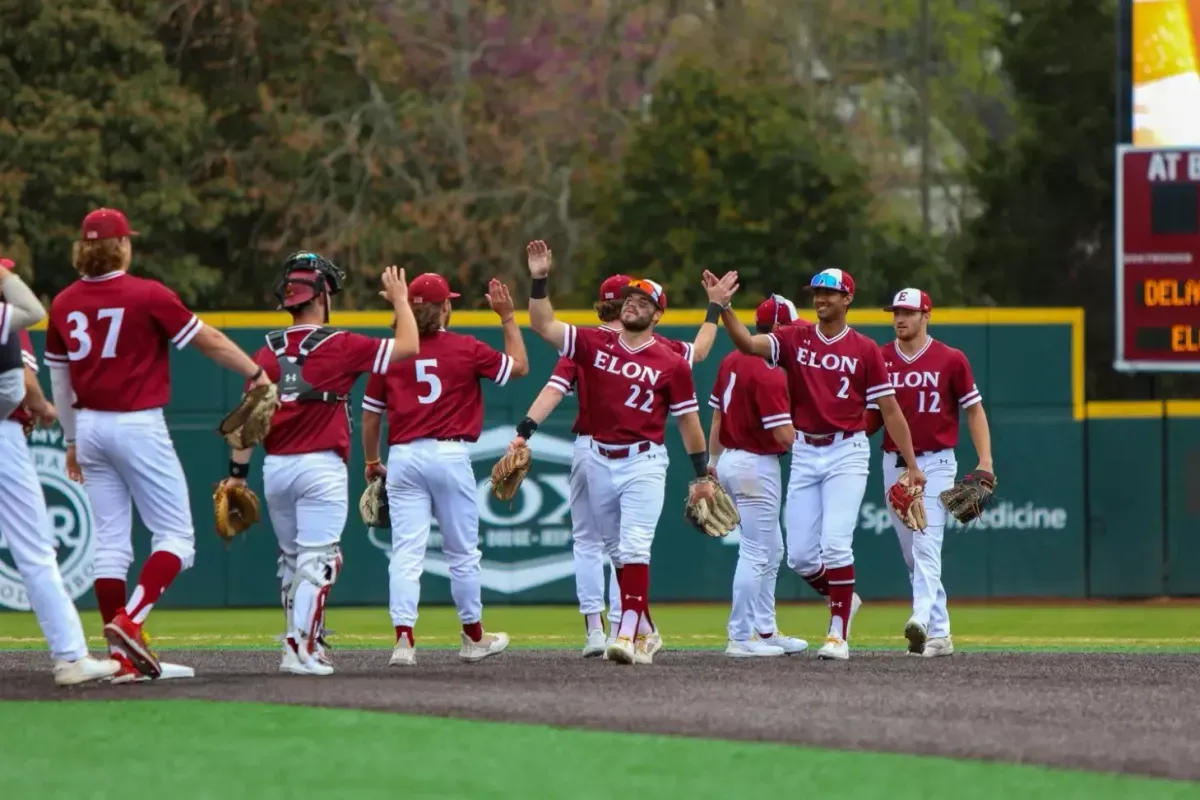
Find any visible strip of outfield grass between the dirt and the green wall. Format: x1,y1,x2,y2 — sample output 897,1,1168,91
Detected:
0,602,1200,652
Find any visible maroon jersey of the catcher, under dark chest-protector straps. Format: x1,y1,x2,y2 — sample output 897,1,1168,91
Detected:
247,325,395,461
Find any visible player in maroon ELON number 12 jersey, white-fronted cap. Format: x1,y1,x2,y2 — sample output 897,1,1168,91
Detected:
866,289,994,658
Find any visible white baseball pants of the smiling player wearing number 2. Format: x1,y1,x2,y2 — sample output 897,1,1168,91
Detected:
785,432,871,576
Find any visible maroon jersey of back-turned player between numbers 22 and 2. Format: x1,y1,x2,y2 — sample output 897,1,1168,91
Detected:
708,350,792,456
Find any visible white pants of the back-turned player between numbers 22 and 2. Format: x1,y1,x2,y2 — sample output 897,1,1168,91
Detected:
716,450,784,642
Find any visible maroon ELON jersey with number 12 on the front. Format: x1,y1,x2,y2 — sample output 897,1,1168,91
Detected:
880,338,983,452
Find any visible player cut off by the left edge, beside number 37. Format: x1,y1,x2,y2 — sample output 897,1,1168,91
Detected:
0,259,120,686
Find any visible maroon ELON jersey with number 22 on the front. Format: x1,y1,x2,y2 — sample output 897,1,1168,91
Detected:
559,325,700,445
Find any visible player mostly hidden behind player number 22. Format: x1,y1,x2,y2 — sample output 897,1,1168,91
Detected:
518,275,716,658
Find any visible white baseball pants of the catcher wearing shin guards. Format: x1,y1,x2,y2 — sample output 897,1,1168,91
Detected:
263,450,350,636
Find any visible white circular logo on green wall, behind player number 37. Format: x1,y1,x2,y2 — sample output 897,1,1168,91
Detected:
0,441,94,610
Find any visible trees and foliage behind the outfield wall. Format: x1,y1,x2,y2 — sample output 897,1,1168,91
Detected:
0,0,1180,397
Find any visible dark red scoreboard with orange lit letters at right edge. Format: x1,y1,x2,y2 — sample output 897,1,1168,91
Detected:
1114,145,1200,372
